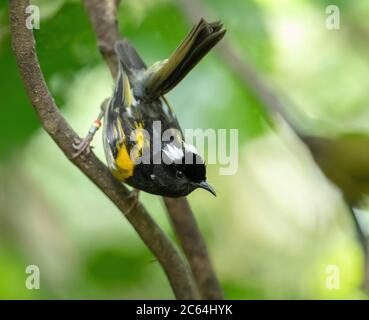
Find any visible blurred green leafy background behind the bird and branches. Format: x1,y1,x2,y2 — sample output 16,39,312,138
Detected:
0,0,369,299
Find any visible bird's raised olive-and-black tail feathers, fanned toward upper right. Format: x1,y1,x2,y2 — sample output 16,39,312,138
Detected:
145,19,226,99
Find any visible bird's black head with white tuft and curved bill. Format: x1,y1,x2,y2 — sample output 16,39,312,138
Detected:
131,144,216,198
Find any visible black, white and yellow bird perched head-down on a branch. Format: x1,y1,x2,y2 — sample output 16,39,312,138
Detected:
74,18,226,198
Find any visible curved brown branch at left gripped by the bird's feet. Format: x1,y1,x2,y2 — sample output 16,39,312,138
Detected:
9,0,196,299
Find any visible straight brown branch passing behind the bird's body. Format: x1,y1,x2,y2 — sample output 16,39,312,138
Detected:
83,0,223,299
